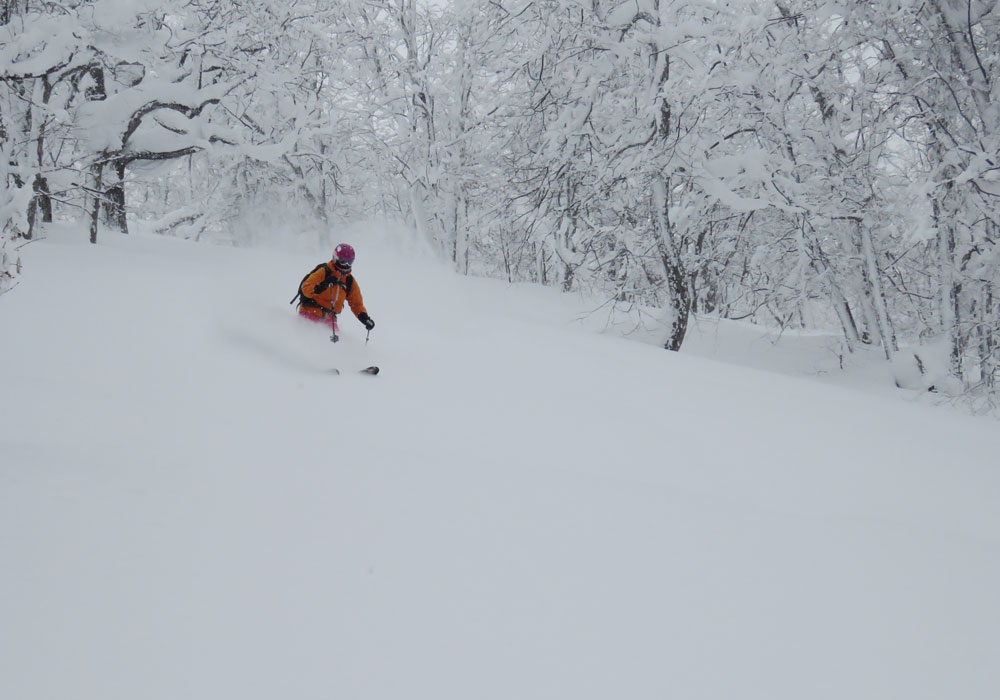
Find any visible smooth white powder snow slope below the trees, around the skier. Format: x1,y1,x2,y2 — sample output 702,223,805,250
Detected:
0,226,1000,700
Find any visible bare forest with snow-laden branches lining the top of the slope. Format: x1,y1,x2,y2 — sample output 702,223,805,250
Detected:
0,0,1000,401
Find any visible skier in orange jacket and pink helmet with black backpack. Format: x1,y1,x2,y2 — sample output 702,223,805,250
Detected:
292,243,375,340
